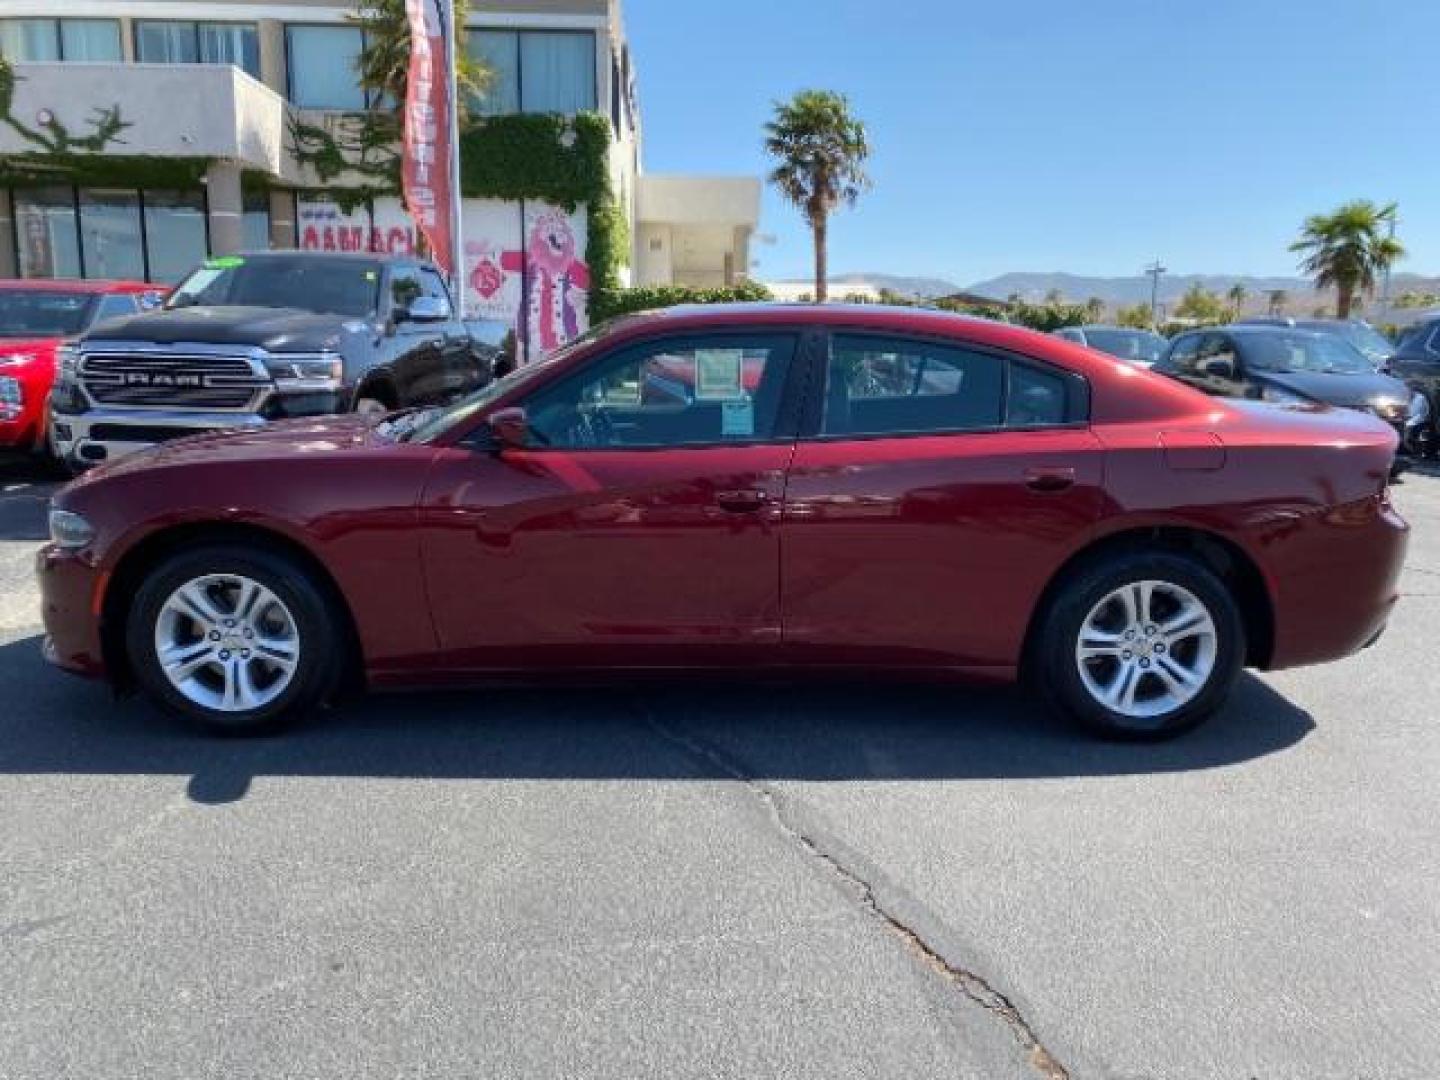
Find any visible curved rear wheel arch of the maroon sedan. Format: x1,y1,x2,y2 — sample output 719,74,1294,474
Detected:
1021,526,1274,670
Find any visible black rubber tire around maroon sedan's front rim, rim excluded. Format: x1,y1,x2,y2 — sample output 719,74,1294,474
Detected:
125,544,346,736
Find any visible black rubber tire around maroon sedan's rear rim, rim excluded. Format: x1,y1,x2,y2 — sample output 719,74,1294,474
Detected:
1031,552,1246,742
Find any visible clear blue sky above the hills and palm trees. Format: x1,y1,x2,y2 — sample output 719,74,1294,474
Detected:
625,0,1440,285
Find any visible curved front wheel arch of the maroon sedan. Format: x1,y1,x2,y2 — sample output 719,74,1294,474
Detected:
101,521,364,690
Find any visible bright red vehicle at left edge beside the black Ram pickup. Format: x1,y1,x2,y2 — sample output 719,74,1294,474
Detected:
0,279,168,455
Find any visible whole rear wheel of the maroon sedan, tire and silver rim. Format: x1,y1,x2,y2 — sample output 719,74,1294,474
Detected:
1037,553,1246,739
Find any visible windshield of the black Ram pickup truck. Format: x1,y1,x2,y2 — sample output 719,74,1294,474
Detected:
166,255,380,318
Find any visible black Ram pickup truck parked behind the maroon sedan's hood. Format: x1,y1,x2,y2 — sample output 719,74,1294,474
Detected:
50,252,495,469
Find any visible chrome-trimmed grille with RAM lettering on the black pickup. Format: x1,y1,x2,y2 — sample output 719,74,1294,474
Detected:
79,350,274,412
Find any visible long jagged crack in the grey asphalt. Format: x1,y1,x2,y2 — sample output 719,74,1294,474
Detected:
641,707,1070,1080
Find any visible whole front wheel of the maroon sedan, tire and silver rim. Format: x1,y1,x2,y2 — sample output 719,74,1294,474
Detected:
125,546,343,734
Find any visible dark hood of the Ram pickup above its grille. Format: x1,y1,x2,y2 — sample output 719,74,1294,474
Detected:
82,307,357,353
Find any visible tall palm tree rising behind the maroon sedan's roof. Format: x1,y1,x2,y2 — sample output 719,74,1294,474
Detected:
765,91,870,304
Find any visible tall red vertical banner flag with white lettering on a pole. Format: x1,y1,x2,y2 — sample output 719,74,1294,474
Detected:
400,0,458,278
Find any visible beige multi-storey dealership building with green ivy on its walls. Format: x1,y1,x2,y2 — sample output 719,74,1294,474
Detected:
0,0,760,338
